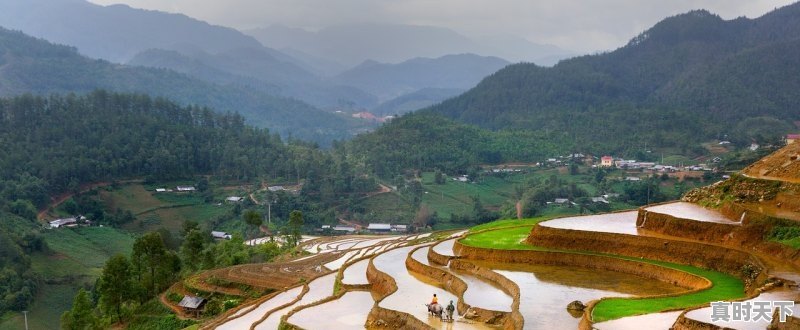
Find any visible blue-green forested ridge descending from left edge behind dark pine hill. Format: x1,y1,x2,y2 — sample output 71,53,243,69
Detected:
0,28,360,143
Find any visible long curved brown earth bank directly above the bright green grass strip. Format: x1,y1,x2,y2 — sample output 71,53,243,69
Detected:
515,226,765,282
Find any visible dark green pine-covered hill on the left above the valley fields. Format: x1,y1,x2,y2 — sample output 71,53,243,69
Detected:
0,91,377,315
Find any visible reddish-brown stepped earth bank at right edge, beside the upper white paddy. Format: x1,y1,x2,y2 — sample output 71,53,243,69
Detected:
636,203,800,267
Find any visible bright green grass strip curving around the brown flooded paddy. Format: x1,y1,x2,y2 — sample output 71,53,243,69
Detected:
461,218,744,322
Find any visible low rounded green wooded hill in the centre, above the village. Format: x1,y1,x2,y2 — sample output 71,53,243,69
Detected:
348,113,570,179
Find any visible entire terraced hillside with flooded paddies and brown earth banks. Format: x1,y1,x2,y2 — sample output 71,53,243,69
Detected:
182,145,800,329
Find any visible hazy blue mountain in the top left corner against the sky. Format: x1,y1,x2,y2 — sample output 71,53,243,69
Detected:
0,0,261,63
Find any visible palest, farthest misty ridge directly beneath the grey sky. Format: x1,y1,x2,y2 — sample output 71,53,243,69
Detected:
245,24,572,67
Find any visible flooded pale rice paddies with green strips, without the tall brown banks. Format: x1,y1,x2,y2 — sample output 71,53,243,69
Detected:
198,203,800,330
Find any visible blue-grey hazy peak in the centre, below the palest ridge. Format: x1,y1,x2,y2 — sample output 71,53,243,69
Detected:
332,54,509,101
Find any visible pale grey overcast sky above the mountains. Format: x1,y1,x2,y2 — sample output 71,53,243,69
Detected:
90,0,794,53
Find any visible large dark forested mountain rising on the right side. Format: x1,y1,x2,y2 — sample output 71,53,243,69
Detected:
427,4,800,152
